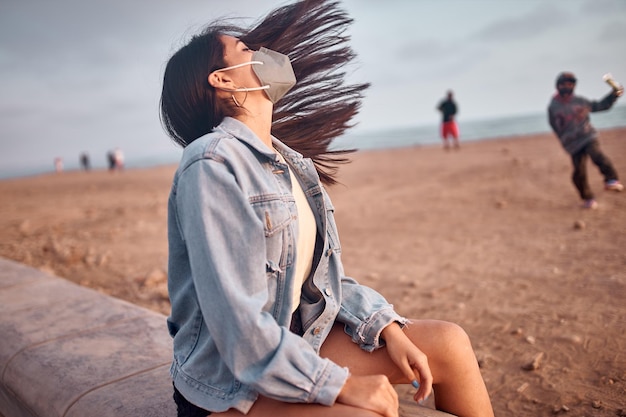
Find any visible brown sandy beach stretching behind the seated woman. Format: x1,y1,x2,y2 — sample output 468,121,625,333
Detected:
0,128,626,417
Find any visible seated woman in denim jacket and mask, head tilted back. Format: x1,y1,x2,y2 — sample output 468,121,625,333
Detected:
161,0,493,417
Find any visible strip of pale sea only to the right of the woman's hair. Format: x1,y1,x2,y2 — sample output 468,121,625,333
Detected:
334,105,626,150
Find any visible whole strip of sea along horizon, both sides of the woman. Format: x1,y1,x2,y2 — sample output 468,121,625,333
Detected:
0,105,626,179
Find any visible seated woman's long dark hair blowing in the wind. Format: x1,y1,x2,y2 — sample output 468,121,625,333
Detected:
161,0,368,184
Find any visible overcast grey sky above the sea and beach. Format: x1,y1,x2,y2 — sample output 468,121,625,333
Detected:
0,0,626,173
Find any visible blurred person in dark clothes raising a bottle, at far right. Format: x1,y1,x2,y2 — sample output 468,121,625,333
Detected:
548,72,624,209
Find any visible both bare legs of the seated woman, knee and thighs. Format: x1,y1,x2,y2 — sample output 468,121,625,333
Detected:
212,320,493,417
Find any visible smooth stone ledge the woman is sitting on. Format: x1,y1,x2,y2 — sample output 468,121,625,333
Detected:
0,258,450,417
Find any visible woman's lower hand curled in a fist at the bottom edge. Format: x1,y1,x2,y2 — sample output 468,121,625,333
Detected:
337,375,399,417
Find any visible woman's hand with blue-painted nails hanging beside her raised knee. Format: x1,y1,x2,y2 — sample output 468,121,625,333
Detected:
381,323,433,402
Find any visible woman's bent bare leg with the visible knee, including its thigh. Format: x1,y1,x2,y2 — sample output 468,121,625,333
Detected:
320,320,493,417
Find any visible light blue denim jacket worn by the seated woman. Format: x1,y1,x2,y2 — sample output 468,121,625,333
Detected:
167,118,406,413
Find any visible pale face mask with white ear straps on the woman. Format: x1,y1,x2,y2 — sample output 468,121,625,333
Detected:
216,48,296,105
